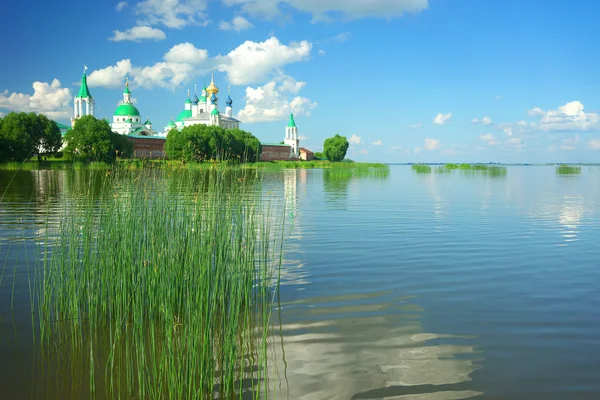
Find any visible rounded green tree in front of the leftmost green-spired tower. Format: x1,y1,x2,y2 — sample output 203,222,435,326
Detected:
64,115,116,161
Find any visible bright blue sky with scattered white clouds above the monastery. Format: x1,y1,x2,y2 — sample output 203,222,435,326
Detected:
0,0,600,163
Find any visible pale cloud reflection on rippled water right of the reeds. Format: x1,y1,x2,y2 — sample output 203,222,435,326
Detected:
269,298,481,400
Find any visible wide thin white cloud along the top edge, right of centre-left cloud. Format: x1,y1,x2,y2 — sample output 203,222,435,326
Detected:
225,0,428,21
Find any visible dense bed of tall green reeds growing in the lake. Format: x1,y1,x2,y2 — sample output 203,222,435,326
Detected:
35,169,281,399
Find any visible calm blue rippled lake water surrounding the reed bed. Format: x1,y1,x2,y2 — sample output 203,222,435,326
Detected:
0,166,600,400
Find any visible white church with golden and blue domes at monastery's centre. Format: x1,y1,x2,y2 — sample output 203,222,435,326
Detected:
163,72,240,136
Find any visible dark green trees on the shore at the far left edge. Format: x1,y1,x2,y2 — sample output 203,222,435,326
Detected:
0,112,62,162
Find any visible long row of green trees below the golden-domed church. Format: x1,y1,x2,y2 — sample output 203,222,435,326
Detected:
165,124,261,163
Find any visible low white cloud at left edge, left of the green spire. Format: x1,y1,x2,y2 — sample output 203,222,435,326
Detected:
0,79,73,118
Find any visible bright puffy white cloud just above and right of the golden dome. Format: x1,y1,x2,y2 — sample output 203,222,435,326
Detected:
217,37,312,85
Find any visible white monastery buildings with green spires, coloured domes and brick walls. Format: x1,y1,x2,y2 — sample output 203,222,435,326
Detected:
71,68,314,161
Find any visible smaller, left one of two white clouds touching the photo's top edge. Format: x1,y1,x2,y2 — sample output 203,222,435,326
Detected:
135,0,210,29
